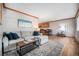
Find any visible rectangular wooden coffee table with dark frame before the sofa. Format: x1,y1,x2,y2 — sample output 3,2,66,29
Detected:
16,40,36,56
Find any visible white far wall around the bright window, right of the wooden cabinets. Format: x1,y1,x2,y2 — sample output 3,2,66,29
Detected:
50,19,75,37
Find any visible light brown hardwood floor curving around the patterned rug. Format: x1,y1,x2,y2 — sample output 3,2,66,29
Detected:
49,36,79,56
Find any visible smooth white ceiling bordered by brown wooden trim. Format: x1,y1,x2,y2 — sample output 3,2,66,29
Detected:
6,3,78,22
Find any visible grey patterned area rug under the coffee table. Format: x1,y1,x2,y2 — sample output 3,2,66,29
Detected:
5,40,63,56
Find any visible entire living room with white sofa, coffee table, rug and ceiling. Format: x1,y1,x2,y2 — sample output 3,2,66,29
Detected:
0,3,79,56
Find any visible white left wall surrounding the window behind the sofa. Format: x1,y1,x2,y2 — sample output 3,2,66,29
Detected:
3,9,38,31
